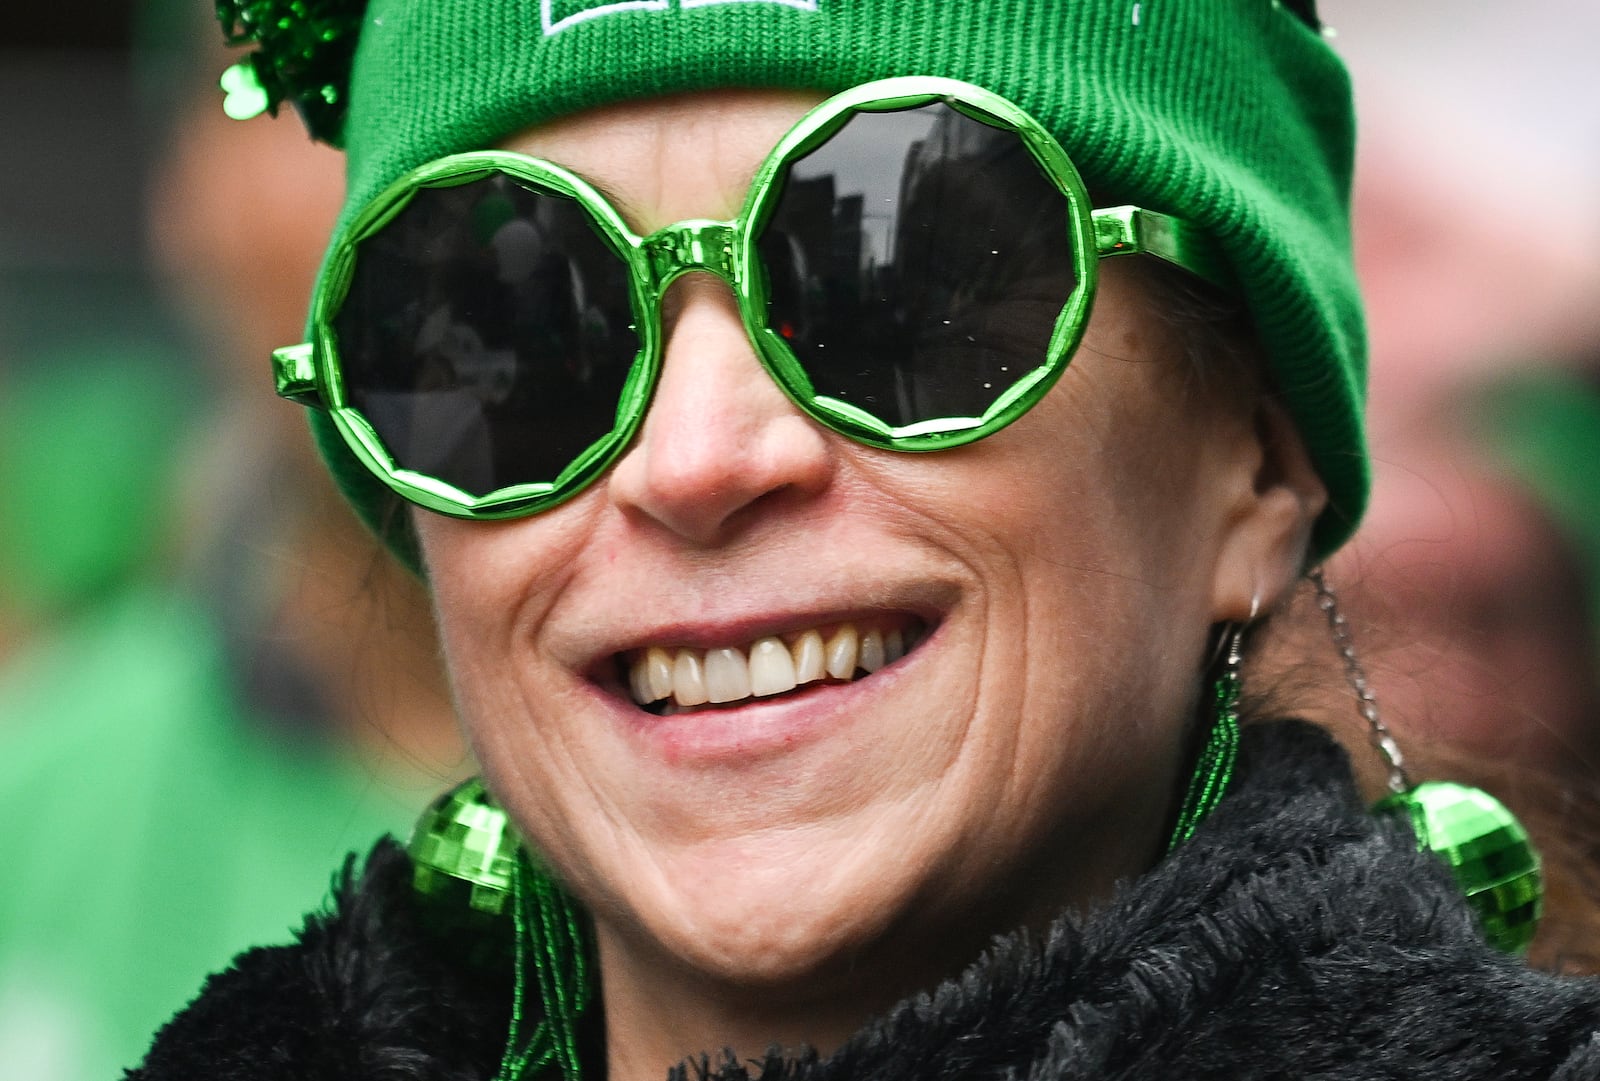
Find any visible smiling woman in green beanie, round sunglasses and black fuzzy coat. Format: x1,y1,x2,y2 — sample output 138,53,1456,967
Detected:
133,0,1600,1081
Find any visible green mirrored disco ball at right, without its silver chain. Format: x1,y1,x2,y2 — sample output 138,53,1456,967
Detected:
1374,780,1544,953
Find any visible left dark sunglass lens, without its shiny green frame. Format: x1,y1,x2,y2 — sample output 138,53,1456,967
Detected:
333,174,638,496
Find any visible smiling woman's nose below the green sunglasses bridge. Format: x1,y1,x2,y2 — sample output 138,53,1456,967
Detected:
608,273,835,547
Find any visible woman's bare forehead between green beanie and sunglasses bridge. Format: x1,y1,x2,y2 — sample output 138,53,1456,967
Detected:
501,90,824,230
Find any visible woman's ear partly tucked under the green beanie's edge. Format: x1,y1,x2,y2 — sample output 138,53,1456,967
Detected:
1211,400,1328,622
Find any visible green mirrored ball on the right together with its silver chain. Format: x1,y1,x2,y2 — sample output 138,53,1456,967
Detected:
1309,569,1544,953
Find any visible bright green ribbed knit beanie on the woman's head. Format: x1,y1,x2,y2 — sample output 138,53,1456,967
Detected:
233,0,1368,558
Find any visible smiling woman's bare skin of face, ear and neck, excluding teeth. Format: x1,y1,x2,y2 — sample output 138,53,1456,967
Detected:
416,91,1322,1079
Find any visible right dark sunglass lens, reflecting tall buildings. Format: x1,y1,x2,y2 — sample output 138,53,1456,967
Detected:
760,104,1077,427
